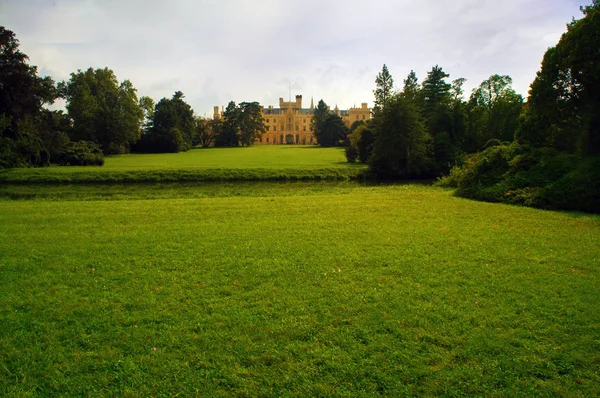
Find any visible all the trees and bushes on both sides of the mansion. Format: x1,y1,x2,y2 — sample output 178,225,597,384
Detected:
0,0,600,212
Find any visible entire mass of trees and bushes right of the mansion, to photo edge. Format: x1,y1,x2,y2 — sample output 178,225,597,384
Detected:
346,0,600,212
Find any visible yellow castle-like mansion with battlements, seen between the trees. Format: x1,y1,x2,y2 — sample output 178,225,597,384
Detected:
214,95,371,145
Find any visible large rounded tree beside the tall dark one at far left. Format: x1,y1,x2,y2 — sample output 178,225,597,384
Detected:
59,68,144,154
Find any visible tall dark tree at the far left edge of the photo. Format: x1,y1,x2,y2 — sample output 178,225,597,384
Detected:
0,26,58,168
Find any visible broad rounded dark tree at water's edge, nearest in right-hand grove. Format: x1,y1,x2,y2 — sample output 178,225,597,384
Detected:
369,95,431,178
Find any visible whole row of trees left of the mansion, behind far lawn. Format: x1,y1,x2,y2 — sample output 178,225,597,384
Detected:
0,26,266,168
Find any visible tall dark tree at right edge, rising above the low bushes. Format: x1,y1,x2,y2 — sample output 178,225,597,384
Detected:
518,1,600,156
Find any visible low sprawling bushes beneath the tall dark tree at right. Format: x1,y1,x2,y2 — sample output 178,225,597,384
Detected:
440,142,600,213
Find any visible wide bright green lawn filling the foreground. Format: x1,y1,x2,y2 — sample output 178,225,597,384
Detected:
0,184,600,397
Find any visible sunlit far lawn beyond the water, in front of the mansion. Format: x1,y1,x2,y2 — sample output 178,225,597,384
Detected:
0,145,365,183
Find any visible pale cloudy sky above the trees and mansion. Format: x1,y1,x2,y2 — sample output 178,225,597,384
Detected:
0,0,591,117
